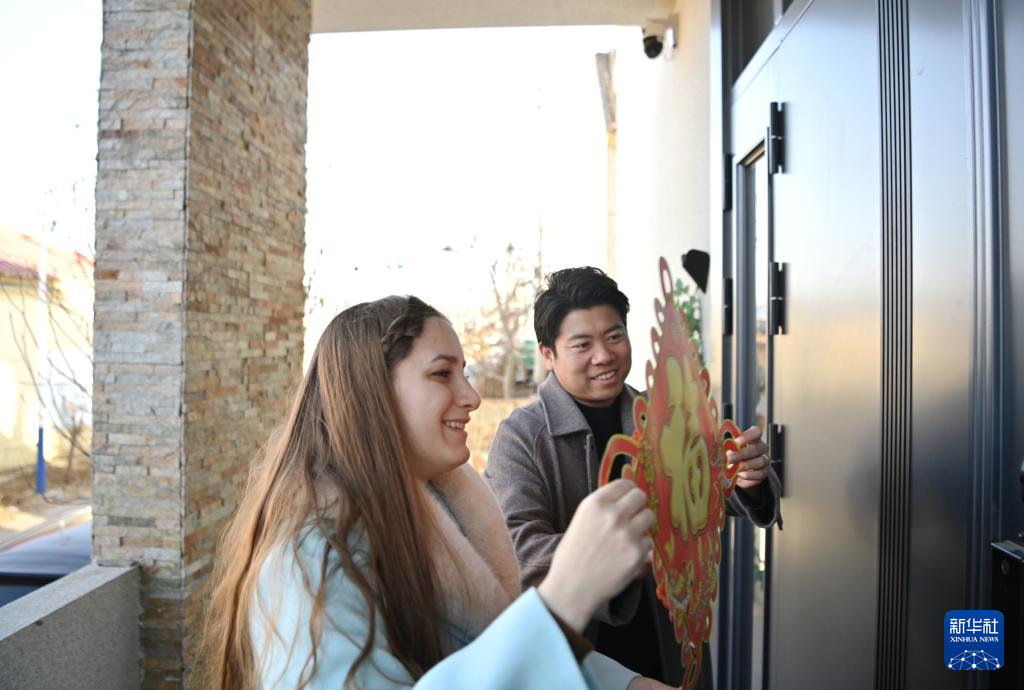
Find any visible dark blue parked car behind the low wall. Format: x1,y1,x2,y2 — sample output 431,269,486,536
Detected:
0,508,92,606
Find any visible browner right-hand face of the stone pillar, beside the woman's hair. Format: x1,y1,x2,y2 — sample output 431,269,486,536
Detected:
184,0,311,667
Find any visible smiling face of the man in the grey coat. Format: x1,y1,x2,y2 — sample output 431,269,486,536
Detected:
541,304,633,407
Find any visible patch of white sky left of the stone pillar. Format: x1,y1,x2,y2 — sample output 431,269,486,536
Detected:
0,0,102,249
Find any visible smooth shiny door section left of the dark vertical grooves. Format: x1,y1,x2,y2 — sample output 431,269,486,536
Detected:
729,0,882,690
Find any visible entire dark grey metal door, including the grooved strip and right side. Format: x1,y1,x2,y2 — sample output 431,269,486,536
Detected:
719,0,1011,690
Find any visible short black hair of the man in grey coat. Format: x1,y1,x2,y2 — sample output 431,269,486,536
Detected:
534,266,630,350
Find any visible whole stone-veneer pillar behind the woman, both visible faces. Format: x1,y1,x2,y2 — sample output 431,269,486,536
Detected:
93,0,311,688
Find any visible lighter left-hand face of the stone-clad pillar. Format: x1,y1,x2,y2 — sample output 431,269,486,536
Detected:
92,5,190,687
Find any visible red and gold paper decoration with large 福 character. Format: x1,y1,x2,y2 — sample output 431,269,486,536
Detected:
600,258,740,689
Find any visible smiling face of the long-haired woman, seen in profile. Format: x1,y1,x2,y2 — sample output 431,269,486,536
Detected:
391,316,480,481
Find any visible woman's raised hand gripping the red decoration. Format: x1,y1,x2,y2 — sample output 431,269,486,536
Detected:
538,479,654,633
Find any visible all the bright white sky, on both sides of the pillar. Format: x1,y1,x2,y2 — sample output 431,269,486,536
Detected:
0,0,639,333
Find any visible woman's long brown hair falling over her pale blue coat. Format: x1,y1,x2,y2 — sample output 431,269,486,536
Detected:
198,297,443,690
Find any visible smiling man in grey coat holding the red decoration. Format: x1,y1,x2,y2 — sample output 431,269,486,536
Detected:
484,267,778,689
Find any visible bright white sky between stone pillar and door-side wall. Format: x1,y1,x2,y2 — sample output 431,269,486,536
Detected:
306,28,637,333
